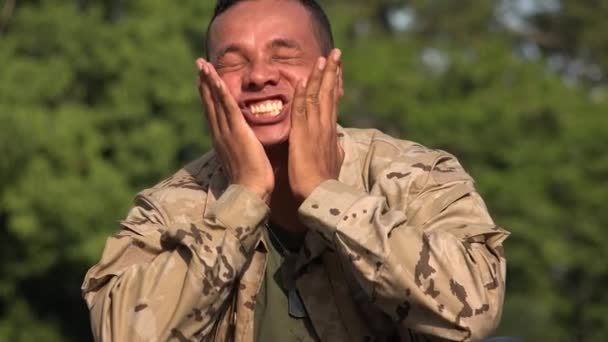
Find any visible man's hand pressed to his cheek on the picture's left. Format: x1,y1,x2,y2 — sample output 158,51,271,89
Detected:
196,58,274,203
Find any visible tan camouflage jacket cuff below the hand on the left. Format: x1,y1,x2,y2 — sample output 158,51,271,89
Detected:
213,184,270,240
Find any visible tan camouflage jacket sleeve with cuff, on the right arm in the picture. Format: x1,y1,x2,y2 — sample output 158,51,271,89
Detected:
299,153,508,341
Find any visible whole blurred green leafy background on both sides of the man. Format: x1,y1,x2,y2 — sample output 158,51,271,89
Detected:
0,0,608,341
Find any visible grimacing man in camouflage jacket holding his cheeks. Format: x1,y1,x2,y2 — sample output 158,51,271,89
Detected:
83,0,507,341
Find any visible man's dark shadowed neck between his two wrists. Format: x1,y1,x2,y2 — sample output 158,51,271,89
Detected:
265,143,307,233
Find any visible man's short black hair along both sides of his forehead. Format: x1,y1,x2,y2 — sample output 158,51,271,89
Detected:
205,0,334,55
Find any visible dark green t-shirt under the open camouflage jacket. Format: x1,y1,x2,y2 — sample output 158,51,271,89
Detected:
255,224,319,342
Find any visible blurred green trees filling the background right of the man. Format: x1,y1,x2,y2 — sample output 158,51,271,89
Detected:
336,1,608,341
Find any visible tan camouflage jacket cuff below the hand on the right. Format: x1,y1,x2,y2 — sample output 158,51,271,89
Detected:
298,179,366,240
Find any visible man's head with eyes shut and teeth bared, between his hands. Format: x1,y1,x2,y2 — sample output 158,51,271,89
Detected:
208,0,321,146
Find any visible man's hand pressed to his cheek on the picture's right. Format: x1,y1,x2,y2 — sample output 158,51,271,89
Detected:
288,49,344,200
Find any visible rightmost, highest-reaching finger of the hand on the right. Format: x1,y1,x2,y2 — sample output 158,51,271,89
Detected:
319,49,342,124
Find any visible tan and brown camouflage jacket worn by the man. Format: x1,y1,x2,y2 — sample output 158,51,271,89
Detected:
82,128,508,342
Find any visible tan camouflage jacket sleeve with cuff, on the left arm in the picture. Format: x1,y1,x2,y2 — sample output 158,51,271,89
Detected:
82,185,268,341
